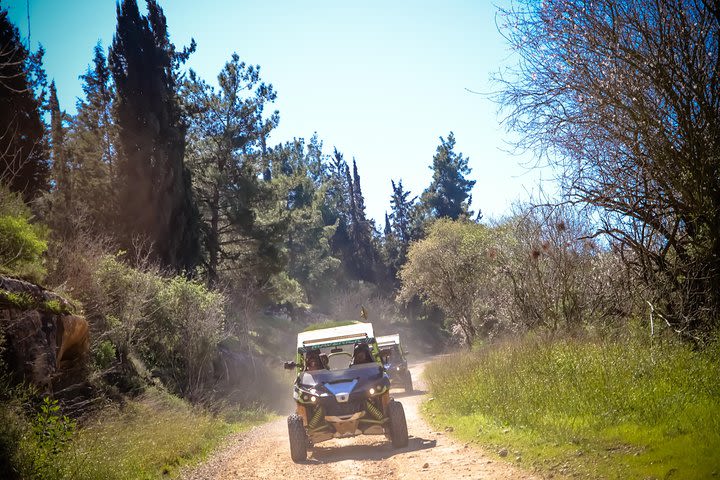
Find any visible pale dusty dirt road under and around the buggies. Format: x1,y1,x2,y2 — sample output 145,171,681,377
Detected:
182,362,538,480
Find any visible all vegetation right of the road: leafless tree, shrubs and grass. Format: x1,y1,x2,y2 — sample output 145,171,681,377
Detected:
416,0,720,479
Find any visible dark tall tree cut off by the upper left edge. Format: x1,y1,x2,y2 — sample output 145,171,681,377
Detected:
0,7,50,201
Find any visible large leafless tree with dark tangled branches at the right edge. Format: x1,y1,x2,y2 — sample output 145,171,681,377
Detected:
499,0,720,336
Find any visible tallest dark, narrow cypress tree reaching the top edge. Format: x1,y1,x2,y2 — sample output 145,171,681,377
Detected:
109,0,200,272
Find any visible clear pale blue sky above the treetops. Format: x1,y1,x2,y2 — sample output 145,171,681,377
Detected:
7,0,550,226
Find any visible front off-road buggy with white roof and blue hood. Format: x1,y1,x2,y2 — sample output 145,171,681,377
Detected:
285,323,408,462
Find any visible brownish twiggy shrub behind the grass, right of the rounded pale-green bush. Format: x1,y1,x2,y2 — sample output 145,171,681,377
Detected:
497,204,633,334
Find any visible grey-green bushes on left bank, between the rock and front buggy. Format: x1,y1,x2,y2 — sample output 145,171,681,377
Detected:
88,257,225,401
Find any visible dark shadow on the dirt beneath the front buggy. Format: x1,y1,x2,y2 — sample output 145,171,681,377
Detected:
307,437,437,464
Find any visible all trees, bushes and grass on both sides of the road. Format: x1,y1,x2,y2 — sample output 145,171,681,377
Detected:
0,0,720,479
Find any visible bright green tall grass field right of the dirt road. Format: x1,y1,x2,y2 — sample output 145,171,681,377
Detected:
424,339,720,479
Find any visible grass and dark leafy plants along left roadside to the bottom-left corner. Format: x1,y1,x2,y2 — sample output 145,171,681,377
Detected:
0,390,267,480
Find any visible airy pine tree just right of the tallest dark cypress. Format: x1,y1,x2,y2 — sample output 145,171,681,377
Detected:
184,54,282,286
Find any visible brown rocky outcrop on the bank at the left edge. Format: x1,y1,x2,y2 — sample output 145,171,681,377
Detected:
0,277,90,393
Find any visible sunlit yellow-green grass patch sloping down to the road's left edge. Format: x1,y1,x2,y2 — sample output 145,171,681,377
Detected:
25,391,268,480
